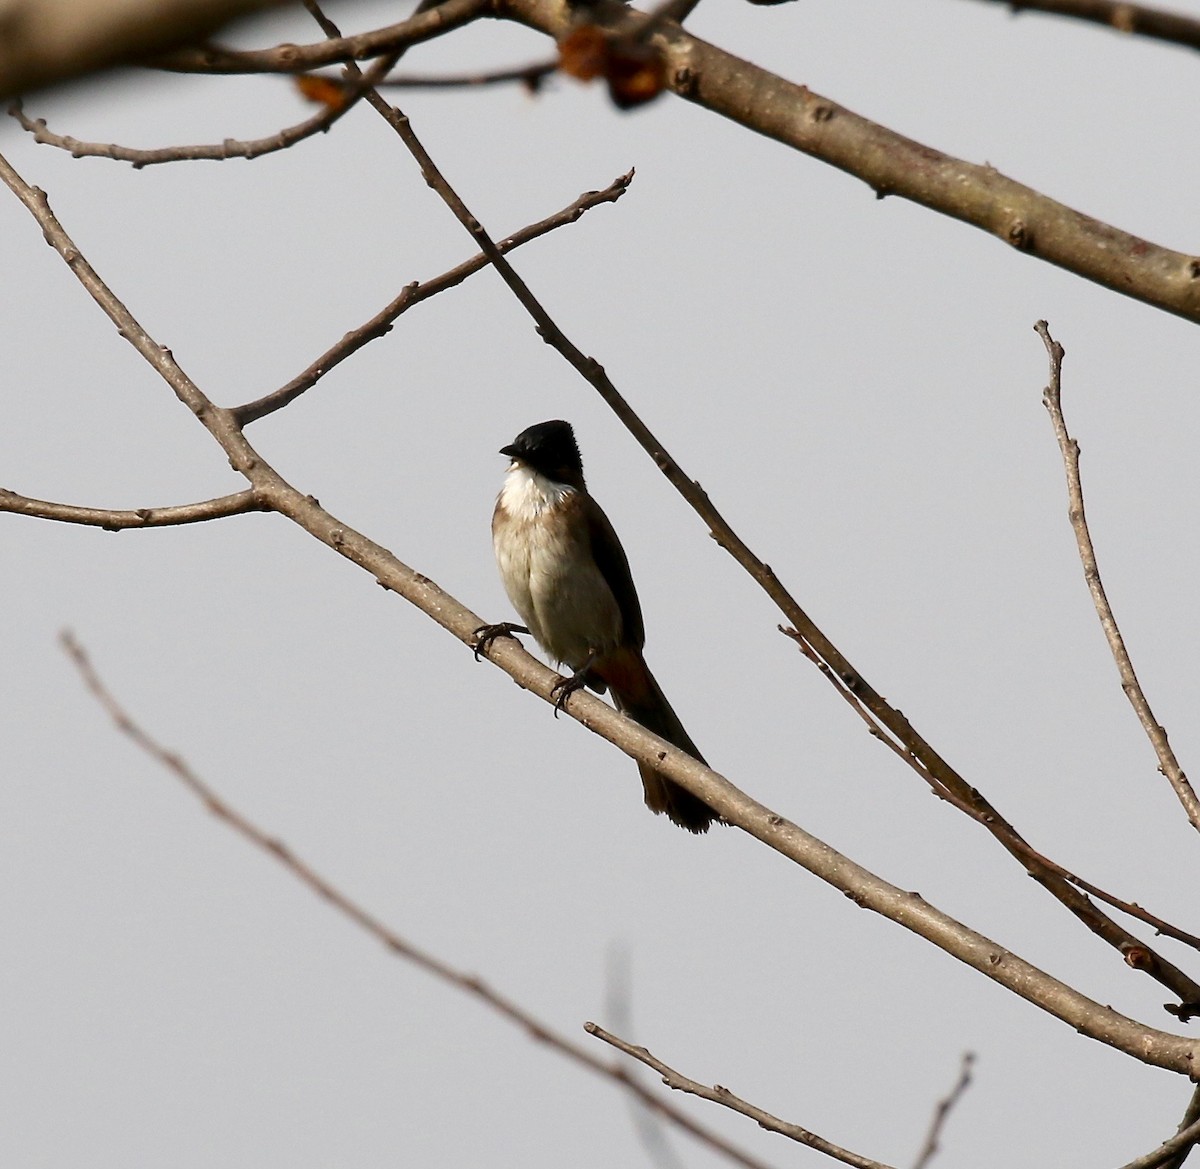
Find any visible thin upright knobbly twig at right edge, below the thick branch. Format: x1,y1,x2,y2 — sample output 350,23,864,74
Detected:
1033,320,1200,832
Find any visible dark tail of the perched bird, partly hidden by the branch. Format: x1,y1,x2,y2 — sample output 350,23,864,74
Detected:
596,651,720,832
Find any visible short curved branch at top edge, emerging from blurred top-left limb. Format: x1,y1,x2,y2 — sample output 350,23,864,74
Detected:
145,0,492,73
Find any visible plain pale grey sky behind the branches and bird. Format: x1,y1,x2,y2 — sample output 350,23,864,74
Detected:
0,0,1200,1169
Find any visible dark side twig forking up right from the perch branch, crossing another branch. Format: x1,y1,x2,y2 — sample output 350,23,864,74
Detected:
234,170,634,426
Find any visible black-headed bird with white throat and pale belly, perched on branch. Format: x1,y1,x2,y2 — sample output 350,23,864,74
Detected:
475,419,720,833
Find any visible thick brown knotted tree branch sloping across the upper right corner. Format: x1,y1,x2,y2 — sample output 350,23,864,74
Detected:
496,0,1200,322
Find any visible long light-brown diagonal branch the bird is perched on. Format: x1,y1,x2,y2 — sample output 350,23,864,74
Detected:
0,156,1200,1078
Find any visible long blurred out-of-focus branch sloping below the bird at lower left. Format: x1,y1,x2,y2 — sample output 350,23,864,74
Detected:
60,631,766,1169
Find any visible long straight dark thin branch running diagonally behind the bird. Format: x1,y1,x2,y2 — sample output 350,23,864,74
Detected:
333,2,1200,1018
